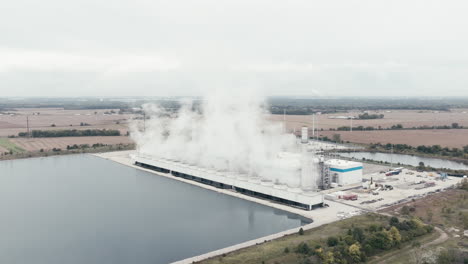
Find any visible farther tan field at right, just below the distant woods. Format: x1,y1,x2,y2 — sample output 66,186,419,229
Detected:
267,109,468,131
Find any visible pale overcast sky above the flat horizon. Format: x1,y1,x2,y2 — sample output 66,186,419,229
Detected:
0,0,468,96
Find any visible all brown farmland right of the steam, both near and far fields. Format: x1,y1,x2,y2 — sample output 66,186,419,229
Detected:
268,109,468,148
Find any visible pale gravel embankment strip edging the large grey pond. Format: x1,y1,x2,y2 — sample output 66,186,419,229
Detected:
91,150,362,264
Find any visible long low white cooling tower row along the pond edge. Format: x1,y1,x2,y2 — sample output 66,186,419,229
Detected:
131,154,324,210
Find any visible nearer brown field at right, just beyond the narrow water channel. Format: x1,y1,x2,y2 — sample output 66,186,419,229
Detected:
319,129,468,148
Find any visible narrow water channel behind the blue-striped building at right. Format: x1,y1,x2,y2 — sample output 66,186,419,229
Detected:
337,152,468,170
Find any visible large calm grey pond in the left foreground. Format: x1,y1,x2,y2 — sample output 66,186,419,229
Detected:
0,155,305,264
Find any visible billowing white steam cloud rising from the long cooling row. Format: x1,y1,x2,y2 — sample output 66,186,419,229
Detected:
131,89,301,187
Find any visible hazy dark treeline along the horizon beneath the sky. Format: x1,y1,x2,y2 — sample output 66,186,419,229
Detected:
0,97,468,115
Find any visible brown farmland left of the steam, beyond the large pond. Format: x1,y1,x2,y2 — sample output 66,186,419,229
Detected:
0,108,138,153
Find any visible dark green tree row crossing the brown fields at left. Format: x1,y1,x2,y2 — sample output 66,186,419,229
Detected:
18,129,120,138
